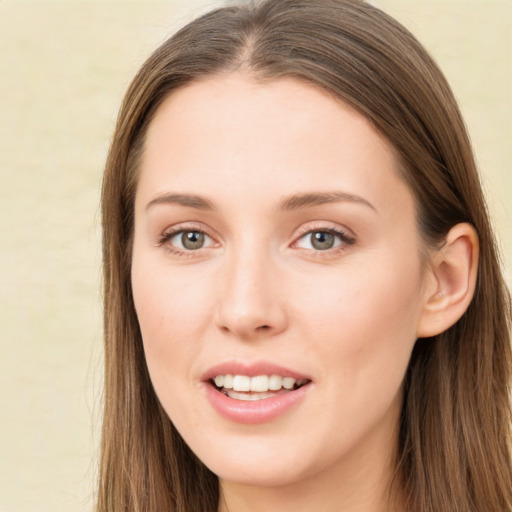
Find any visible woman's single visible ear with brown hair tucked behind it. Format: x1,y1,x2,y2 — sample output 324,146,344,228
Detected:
416,223,479,338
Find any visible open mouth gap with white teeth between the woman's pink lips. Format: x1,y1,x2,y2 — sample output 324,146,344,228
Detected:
208,374,311,401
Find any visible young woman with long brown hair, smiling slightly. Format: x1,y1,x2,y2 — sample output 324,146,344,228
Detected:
98,0,512,512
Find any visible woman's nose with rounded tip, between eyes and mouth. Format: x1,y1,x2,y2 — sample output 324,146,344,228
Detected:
216,250,288,340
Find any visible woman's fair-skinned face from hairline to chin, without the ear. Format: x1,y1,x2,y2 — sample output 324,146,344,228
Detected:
132,73,427,486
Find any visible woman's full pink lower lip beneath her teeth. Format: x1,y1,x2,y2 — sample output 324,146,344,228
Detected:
205,383,311,424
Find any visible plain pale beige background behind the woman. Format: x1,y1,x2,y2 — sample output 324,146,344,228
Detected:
0,0,512,512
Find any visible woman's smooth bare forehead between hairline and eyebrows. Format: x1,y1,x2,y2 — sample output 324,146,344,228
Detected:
137,73,412,216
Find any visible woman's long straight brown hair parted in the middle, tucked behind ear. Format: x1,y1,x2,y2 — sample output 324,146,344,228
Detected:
97,0,512,512
